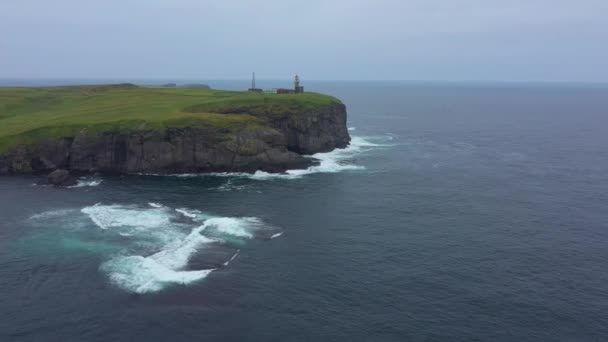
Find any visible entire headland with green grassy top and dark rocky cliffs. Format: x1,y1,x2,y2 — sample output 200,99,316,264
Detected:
0,84,349,173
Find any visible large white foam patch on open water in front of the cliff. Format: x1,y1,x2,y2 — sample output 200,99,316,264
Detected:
75,202,276,293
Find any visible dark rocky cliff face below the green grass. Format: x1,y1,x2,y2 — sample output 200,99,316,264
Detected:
0,104,350,174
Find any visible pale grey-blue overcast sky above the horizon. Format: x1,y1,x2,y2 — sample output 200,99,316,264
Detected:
0,0,608,82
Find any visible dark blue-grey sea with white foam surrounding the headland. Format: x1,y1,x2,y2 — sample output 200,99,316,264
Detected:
0,82,608,342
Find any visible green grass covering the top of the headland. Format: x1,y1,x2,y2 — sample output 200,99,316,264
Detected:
0,84,339,152
